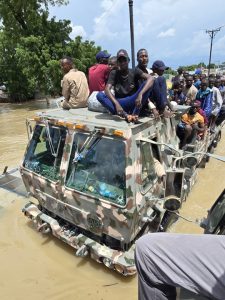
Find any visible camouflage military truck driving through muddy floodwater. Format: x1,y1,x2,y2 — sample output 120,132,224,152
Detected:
20,108,222,275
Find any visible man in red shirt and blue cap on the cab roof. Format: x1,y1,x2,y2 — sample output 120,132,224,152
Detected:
88,51,110,94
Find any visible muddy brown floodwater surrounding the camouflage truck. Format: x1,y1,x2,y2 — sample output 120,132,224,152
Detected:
0,101,225,300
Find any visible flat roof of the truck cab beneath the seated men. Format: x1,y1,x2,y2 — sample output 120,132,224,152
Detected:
37,108,155,134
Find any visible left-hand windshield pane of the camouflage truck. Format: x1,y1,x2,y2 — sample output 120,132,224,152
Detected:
23,124,66,181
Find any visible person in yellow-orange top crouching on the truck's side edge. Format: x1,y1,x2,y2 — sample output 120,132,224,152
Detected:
177,106,205,148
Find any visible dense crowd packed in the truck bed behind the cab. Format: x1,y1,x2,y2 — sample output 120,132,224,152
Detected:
169,68,225,148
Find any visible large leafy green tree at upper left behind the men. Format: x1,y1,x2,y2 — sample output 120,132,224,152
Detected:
0,0,100,101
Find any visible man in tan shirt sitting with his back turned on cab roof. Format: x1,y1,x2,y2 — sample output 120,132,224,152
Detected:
61,57,89,109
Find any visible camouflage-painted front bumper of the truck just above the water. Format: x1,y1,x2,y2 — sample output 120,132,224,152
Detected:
22,202,136,276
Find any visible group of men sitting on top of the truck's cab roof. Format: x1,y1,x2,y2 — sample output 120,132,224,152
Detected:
61,49,167,122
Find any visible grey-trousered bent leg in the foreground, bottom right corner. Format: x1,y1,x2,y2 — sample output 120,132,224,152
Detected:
135,233,225,300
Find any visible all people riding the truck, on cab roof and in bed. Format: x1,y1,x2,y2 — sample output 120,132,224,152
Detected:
61,49,225,148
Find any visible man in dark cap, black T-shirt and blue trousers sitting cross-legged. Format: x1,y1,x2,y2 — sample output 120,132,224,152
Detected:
97,49,154,122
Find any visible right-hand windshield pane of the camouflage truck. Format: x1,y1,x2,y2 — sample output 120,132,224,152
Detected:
66,133,126,206
